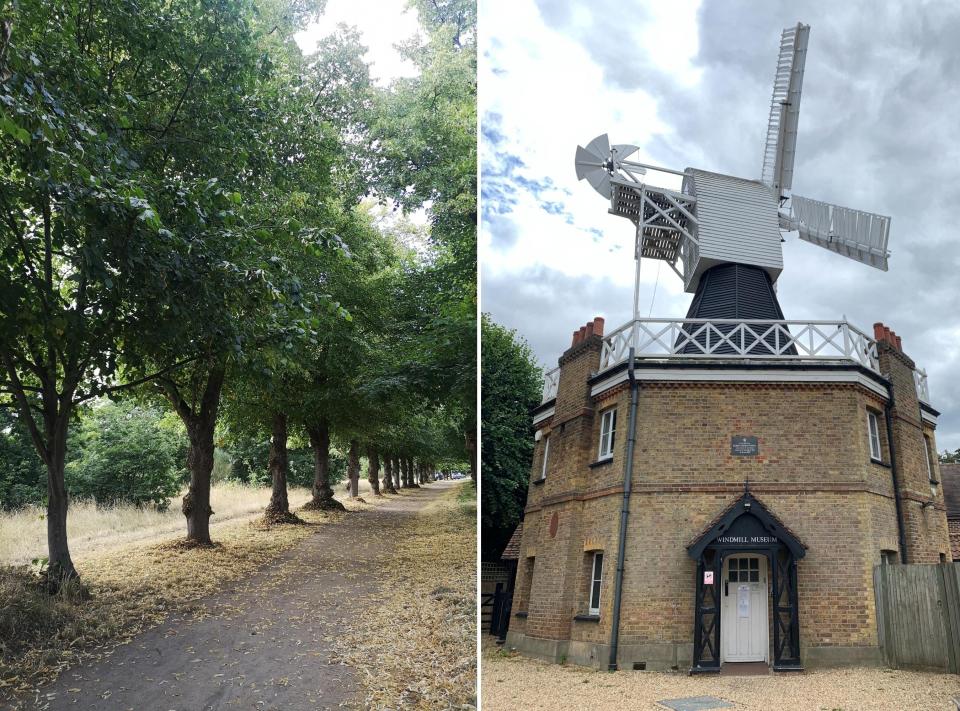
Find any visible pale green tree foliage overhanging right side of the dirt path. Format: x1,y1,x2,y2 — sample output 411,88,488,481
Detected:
371,0,477,480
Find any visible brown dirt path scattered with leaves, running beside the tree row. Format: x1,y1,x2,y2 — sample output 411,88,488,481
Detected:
38,482,455,711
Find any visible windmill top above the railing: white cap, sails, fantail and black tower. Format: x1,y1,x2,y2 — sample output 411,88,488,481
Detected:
576,24,890,320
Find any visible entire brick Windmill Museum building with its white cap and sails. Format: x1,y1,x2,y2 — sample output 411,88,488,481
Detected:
508,25,950,673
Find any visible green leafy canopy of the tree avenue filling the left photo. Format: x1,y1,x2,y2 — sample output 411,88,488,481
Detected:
0,0,476,578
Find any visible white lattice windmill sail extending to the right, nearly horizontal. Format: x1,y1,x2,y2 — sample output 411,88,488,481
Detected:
780,195,890,271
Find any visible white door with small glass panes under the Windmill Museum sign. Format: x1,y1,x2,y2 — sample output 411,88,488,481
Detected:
720,555,768,662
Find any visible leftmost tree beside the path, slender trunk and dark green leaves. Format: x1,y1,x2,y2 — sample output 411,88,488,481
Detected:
0,3,213,585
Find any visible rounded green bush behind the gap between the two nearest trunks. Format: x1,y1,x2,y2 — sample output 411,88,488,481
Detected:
66,401,185,509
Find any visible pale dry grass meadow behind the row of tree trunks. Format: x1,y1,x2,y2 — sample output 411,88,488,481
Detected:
0,480,370,573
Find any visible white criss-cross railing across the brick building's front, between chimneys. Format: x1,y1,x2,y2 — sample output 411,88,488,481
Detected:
600,318,879,372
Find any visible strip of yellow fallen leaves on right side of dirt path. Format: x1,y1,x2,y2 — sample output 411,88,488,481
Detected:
338,483,477,709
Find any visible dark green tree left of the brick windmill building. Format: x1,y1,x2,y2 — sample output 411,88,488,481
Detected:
480,314,543,558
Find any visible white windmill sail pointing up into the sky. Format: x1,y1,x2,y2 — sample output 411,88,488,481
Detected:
761,23,810,197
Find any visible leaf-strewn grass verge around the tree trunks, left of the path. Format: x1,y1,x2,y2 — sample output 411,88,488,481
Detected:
0,490,382,698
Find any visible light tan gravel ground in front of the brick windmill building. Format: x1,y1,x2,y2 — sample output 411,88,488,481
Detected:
481,651,960,711
